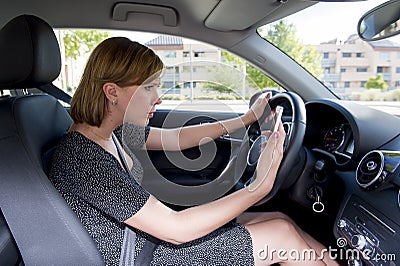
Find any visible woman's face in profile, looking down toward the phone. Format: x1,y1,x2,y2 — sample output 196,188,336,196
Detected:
123,79,161,126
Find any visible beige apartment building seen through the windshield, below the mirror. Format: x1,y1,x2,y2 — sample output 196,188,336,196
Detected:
317,35,400,92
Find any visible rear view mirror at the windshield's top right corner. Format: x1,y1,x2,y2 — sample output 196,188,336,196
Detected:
357,0,400,41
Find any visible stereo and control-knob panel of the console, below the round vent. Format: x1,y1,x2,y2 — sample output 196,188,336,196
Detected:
335,195,400,266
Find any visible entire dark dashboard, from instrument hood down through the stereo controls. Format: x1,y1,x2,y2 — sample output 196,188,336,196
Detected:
296,99,400,265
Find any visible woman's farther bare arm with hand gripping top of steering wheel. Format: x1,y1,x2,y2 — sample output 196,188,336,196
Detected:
145,93,271,151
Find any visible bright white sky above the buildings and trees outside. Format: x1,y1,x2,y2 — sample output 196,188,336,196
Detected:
120,0,400,44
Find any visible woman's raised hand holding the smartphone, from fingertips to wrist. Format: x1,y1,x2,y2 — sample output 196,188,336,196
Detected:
247,122,286,196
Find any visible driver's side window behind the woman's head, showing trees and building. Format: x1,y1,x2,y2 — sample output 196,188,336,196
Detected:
54,29,281,112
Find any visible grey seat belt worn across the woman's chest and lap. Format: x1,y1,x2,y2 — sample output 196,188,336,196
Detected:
112,133,158,266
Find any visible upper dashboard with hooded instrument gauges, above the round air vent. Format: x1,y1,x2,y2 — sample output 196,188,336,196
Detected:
304,99,400,169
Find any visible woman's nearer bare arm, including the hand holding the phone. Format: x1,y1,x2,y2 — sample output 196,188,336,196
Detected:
125,122,285,244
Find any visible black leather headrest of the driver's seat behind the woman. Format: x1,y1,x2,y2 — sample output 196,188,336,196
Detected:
0,15,61,89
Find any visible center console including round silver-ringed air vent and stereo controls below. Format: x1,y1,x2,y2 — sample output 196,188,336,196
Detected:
334,150,400,266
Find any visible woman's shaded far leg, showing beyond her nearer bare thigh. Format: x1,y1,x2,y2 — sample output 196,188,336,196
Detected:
237,212,339,265
